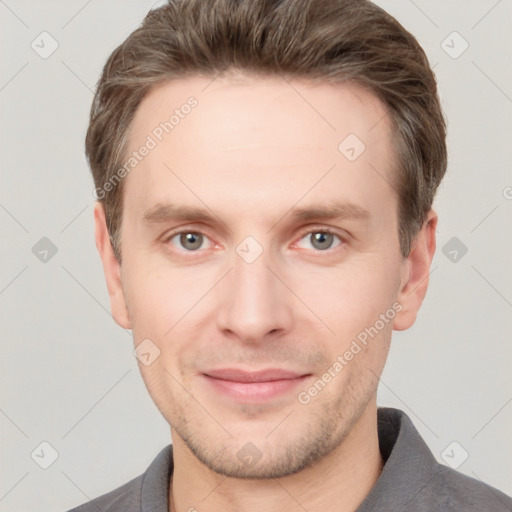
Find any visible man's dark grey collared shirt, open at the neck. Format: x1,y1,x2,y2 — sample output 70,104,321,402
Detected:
69,408,512,512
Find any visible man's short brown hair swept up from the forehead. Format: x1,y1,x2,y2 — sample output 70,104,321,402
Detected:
86,0,447,261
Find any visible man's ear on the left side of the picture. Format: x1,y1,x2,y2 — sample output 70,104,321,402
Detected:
94,201,131,329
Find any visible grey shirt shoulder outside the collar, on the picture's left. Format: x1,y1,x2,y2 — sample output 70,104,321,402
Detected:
68,474,144,512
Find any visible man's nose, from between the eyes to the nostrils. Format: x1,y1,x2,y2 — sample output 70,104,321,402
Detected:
217,244,293,344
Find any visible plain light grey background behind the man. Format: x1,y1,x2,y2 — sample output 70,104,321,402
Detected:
0,0,512,512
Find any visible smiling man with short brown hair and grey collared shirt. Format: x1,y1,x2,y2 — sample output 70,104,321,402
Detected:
70,0,512,512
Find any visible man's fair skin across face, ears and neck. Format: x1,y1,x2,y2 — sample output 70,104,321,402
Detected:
95,74,437,512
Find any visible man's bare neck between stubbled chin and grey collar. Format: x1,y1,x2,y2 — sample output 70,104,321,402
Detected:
169,398,383,512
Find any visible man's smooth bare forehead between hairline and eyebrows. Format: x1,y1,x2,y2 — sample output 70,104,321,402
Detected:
125,75,394,224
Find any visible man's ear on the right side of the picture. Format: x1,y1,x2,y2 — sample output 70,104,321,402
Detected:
393,210,438,331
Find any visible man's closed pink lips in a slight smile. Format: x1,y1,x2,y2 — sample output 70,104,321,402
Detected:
201,368,311,403
